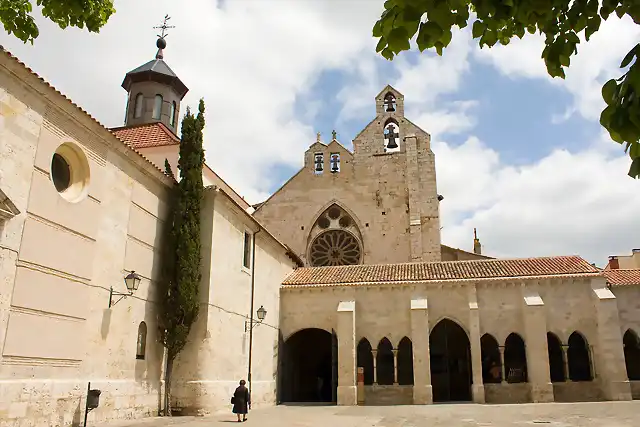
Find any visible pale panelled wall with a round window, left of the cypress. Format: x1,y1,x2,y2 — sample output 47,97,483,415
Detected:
0,47,174,427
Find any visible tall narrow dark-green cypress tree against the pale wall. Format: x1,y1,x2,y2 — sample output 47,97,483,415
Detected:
158,99,204,415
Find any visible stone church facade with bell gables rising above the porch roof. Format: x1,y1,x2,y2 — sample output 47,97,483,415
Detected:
255,87,441,264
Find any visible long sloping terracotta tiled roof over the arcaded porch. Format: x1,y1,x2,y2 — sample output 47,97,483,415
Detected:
283,256,600,286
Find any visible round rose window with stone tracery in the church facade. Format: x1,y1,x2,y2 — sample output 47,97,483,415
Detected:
310,230,362,267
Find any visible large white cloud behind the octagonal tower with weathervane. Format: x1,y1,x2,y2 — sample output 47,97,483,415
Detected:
3,0,382,202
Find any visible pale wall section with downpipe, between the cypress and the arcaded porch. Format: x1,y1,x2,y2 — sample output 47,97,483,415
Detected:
172,190,294,414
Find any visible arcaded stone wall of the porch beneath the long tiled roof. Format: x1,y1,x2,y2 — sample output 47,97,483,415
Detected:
281,278,625,403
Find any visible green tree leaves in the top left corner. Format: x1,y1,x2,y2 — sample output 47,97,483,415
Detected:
0,0,116,44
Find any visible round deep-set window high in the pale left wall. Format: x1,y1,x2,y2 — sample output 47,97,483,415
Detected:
51,143,89,203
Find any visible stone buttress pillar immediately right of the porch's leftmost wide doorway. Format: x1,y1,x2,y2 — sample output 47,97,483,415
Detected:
337,301,358,406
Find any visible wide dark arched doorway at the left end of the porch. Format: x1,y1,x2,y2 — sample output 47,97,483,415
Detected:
281,328,337,403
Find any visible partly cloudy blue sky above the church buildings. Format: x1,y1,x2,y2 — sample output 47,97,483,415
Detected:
0,0,640,267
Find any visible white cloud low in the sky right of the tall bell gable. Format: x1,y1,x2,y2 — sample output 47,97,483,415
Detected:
433,134,640,266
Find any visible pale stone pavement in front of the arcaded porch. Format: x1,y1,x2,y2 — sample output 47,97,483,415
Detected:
96,401,640,427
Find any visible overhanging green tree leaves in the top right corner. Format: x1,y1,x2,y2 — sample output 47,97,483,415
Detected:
373,0,640,178
